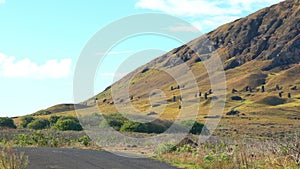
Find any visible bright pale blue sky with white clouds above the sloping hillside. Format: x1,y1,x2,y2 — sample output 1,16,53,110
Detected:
0,0,280,116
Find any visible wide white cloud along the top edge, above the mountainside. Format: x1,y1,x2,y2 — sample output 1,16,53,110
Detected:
135,0,283,17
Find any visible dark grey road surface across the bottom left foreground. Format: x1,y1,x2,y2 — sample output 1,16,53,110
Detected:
16,148,175,169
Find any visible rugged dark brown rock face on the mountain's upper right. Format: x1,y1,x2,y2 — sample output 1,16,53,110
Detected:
198,0,300,70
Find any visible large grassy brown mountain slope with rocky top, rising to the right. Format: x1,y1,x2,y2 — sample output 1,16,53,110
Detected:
28,0,300,137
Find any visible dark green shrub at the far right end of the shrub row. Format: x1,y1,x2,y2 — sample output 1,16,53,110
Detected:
181,120,209,135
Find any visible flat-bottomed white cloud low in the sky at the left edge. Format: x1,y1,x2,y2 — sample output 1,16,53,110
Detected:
0,53,72,79
